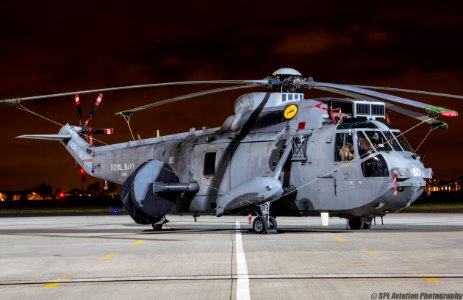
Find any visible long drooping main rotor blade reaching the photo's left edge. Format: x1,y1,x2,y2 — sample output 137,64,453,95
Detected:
0,80,269,106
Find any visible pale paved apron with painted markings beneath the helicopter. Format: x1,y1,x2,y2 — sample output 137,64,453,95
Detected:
0,214,463,299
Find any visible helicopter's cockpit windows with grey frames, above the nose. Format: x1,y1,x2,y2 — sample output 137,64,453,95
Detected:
334,121,413,177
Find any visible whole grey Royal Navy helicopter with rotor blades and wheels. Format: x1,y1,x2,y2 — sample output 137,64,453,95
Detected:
0,68,461,234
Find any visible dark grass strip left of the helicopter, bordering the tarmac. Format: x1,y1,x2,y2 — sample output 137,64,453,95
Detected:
0,206,122,216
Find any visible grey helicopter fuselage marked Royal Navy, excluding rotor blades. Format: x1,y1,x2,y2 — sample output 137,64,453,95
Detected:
59,92,431,223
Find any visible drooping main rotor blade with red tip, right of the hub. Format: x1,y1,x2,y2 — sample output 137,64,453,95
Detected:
302,81,458,117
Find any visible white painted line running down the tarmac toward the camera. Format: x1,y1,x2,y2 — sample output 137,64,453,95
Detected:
235,221,251,300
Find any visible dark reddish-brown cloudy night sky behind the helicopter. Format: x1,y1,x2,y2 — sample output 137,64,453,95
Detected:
0,1,463,190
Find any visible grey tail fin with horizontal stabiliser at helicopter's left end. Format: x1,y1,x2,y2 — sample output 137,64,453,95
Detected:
17,125,93,174
